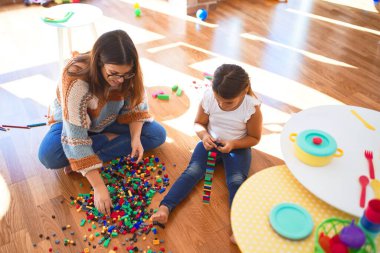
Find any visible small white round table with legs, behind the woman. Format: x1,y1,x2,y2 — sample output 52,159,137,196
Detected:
42,3,103,69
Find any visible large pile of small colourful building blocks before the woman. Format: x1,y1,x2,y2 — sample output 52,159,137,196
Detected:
34,156,169,253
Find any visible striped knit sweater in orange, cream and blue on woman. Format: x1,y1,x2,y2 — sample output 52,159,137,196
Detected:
48,70,152,175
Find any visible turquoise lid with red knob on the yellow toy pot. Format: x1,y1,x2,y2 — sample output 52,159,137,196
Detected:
296,129,337,156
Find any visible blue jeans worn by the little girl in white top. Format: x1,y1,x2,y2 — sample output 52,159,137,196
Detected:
160,141,252,211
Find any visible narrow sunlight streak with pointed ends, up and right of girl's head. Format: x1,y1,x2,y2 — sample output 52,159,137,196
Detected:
241,33,357,69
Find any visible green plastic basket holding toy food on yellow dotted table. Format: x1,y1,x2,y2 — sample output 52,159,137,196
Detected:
314,218,376,253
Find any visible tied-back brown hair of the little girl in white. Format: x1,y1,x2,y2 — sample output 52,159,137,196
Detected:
212,64,256,99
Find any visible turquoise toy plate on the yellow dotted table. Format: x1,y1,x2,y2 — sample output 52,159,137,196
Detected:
269,203,314,240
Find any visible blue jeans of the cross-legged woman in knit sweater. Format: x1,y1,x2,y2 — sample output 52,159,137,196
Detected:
38,121,166,169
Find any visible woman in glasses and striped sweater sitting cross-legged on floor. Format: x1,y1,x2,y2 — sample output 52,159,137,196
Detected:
38,30,166,214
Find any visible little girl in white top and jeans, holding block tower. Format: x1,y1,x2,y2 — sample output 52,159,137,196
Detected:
152,64,262,236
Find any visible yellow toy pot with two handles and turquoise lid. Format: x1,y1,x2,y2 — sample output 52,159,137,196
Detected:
289,129,343,167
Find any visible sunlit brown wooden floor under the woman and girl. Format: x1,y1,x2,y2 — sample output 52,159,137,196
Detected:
0,0,380,253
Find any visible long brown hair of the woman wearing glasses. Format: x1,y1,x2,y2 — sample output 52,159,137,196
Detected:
66,30,144,107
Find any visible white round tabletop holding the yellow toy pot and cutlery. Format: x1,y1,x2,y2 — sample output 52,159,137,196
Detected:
281,105,380,217
